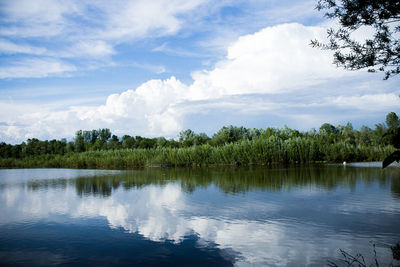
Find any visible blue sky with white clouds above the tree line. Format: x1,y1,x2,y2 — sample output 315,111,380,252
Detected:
0,0,400,143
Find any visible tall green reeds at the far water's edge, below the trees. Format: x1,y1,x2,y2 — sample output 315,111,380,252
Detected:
0,136,394,169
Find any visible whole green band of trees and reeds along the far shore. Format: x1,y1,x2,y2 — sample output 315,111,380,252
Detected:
0,112,400,168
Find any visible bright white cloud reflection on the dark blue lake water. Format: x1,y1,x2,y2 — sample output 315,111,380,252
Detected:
0,180,318,264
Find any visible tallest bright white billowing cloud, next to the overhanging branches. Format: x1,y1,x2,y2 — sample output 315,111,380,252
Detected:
188,24,350,99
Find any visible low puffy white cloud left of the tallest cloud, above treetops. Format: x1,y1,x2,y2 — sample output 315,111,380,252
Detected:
0,77,187,142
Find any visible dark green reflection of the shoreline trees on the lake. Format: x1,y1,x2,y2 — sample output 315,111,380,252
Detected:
23,165,400,199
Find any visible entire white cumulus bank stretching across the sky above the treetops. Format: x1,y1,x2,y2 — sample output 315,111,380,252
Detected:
0,23,400,144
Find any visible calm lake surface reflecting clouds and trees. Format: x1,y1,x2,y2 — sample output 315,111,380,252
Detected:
0,164,400,266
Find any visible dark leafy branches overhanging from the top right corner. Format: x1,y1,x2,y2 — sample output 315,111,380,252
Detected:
311,0,400,79
